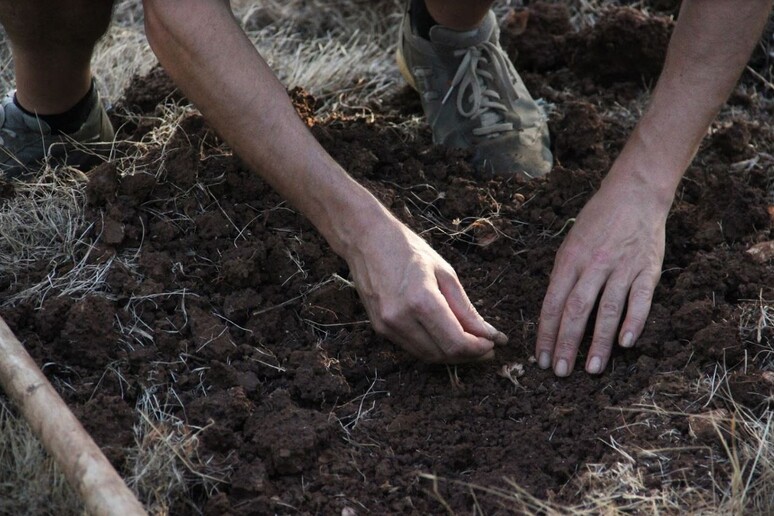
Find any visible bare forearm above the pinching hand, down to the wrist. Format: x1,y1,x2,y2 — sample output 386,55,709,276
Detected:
145,0,389,254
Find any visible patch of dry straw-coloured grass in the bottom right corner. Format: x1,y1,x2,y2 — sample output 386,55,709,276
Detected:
420,390,774,516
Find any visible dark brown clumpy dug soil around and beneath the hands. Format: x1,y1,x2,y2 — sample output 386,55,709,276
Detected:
1,2,774,515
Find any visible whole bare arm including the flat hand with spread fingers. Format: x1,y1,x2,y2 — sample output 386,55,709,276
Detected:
535,0,772,376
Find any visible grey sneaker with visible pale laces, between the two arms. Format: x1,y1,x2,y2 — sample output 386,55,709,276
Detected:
396,4,553,178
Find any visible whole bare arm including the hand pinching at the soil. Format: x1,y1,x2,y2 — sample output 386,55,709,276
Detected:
144,0,505,362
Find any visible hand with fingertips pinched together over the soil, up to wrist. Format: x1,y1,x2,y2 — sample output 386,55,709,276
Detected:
344,216,508,364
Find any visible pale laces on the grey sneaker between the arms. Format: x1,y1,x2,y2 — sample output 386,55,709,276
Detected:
442,41,513,137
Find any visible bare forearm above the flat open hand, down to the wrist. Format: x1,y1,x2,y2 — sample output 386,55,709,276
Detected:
609,0,772,208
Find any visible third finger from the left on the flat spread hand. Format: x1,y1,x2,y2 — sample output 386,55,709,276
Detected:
586,275,631,374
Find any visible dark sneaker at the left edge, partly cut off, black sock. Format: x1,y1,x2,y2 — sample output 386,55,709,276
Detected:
0,86,114,179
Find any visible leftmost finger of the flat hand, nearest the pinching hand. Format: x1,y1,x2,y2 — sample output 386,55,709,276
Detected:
535,264,578,369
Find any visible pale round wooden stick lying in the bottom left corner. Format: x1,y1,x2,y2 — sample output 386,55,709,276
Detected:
0,318,147,516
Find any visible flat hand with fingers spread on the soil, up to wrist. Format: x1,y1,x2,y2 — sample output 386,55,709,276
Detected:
535,172,671,376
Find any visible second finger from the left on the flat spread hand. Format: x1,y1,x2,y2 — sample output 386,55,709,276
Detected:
553,269,607,377
